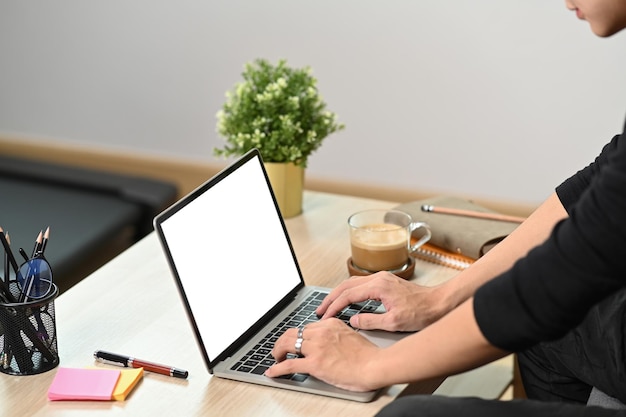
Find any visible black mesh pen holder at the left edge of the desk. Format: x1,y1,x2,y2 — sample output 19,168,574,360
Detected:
0,284,59,375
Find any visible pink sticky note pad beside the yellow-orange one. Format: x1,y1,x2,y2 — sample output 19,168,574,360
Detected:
48,368,120,401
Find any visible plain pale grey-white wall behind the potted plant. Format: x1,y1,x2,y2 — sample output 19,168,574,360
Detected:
0,0,626,204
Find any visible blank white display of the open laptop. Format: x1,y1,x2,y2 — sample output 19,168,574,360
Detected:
161,157,301,360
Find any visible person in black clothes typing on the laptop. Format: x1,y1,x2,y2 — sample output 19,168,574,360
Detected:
266,0,626,416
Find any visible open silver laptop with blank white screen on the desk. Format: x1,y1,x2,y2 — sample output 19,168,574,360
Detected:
154,149,402,402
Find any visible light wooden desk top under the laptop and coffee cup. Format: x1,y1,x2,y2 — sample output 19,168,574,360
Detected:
0,192,456,417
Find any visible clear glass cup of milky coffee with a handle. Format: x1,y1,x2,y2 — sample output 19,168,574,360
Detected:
348,209,431,274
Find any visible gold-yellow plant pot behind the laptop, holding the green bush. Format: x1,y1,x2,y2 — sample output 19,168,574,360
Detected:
264,162,304,219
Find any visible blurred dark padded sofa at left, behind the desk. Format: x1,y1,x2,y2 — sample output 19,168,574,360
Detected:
0,156,177,292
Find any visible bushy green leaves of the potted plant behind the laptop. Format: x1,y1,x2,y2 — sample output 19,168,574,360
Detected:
213,59,345,167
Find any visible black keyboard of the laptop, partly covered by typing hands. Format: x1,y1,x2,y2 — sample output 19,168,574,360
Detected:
231,291,380,381
